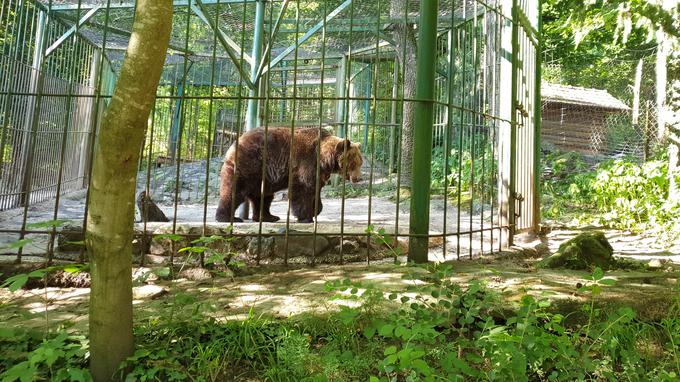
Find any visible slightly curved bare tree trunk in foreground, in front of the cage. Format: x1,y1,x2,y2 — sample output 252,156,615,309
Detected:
85,0,173,381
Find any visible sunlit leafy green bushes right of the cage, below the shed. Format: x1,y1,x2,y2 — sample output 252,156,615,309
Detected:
542,152,680,241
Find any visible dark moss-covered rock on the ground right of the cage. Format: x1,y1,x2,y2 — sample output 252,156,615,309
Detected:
538,232,616,270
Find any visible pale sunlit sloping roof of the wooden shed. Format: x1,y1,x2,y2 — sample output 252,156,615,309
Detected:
541,82,630,110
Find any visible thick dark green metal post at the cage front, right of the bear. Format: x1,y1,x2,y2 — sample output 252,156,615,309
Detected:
408,0,438,263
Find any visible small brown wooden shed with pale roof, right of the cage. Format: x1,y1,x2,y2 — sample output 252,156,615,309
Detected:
541,82,630,154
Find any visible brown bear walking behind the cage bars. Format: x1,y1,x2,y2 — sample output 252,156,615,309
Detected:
215,127,363,223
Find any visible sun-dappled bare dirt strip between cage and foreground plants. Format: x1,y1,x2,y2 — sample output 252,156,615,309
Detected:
0,229,680,330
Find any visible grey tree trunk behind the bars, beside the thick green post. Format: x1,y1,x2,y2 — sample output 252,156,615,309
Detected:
390,0,417,188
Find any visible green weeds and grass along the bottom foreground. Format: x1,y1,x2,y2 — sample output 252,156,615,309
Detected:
0,265,680,382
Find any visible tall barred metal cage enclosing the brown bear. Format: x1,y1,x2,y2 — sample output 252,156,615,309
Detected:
0,0,539,268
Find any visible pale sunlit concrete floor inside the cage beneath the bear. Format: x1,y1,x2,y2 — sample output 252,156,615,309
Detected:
0,192,499,260
